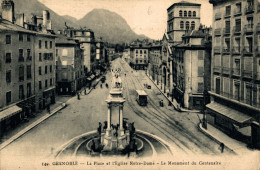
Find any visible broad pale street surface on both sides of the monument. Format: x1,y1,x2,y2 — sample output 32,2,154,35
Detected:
1,59,232,162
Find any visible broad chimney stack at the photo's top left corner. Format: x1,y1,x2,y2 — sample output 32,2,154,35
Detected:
1,0,15,23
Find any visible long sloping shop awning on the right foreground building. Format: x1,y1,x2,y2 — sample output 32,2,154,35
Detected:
206,102,252,125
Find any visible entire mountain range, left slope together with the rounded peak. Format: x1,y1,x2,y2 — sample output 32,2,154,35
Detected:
0,0,149,43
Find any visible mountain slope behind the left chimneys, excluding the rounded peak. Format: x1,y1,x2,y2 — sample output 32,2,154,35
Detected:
0,0,78,30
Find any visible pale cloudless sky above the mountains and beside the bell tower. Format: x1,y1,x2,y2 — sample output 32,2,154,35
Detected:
38,0,213,40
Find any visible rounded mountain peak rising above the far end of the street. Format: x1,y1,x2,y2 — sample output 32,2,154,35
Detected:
76,9,147,43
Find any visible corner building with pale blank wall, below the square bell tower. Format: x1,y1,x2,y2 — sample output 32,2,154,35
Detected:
172,30,211,109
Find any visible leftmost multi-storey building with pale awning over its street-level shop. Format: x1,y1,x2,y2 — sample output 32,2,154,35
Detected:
0,12,35,134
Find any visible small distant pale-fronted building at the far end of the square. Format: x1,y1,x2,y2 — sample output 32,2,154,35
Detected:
130,44,149,70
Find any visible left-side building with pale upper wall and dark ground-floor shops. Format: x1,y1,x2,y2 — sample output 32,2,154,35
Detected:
56,35,85,94
